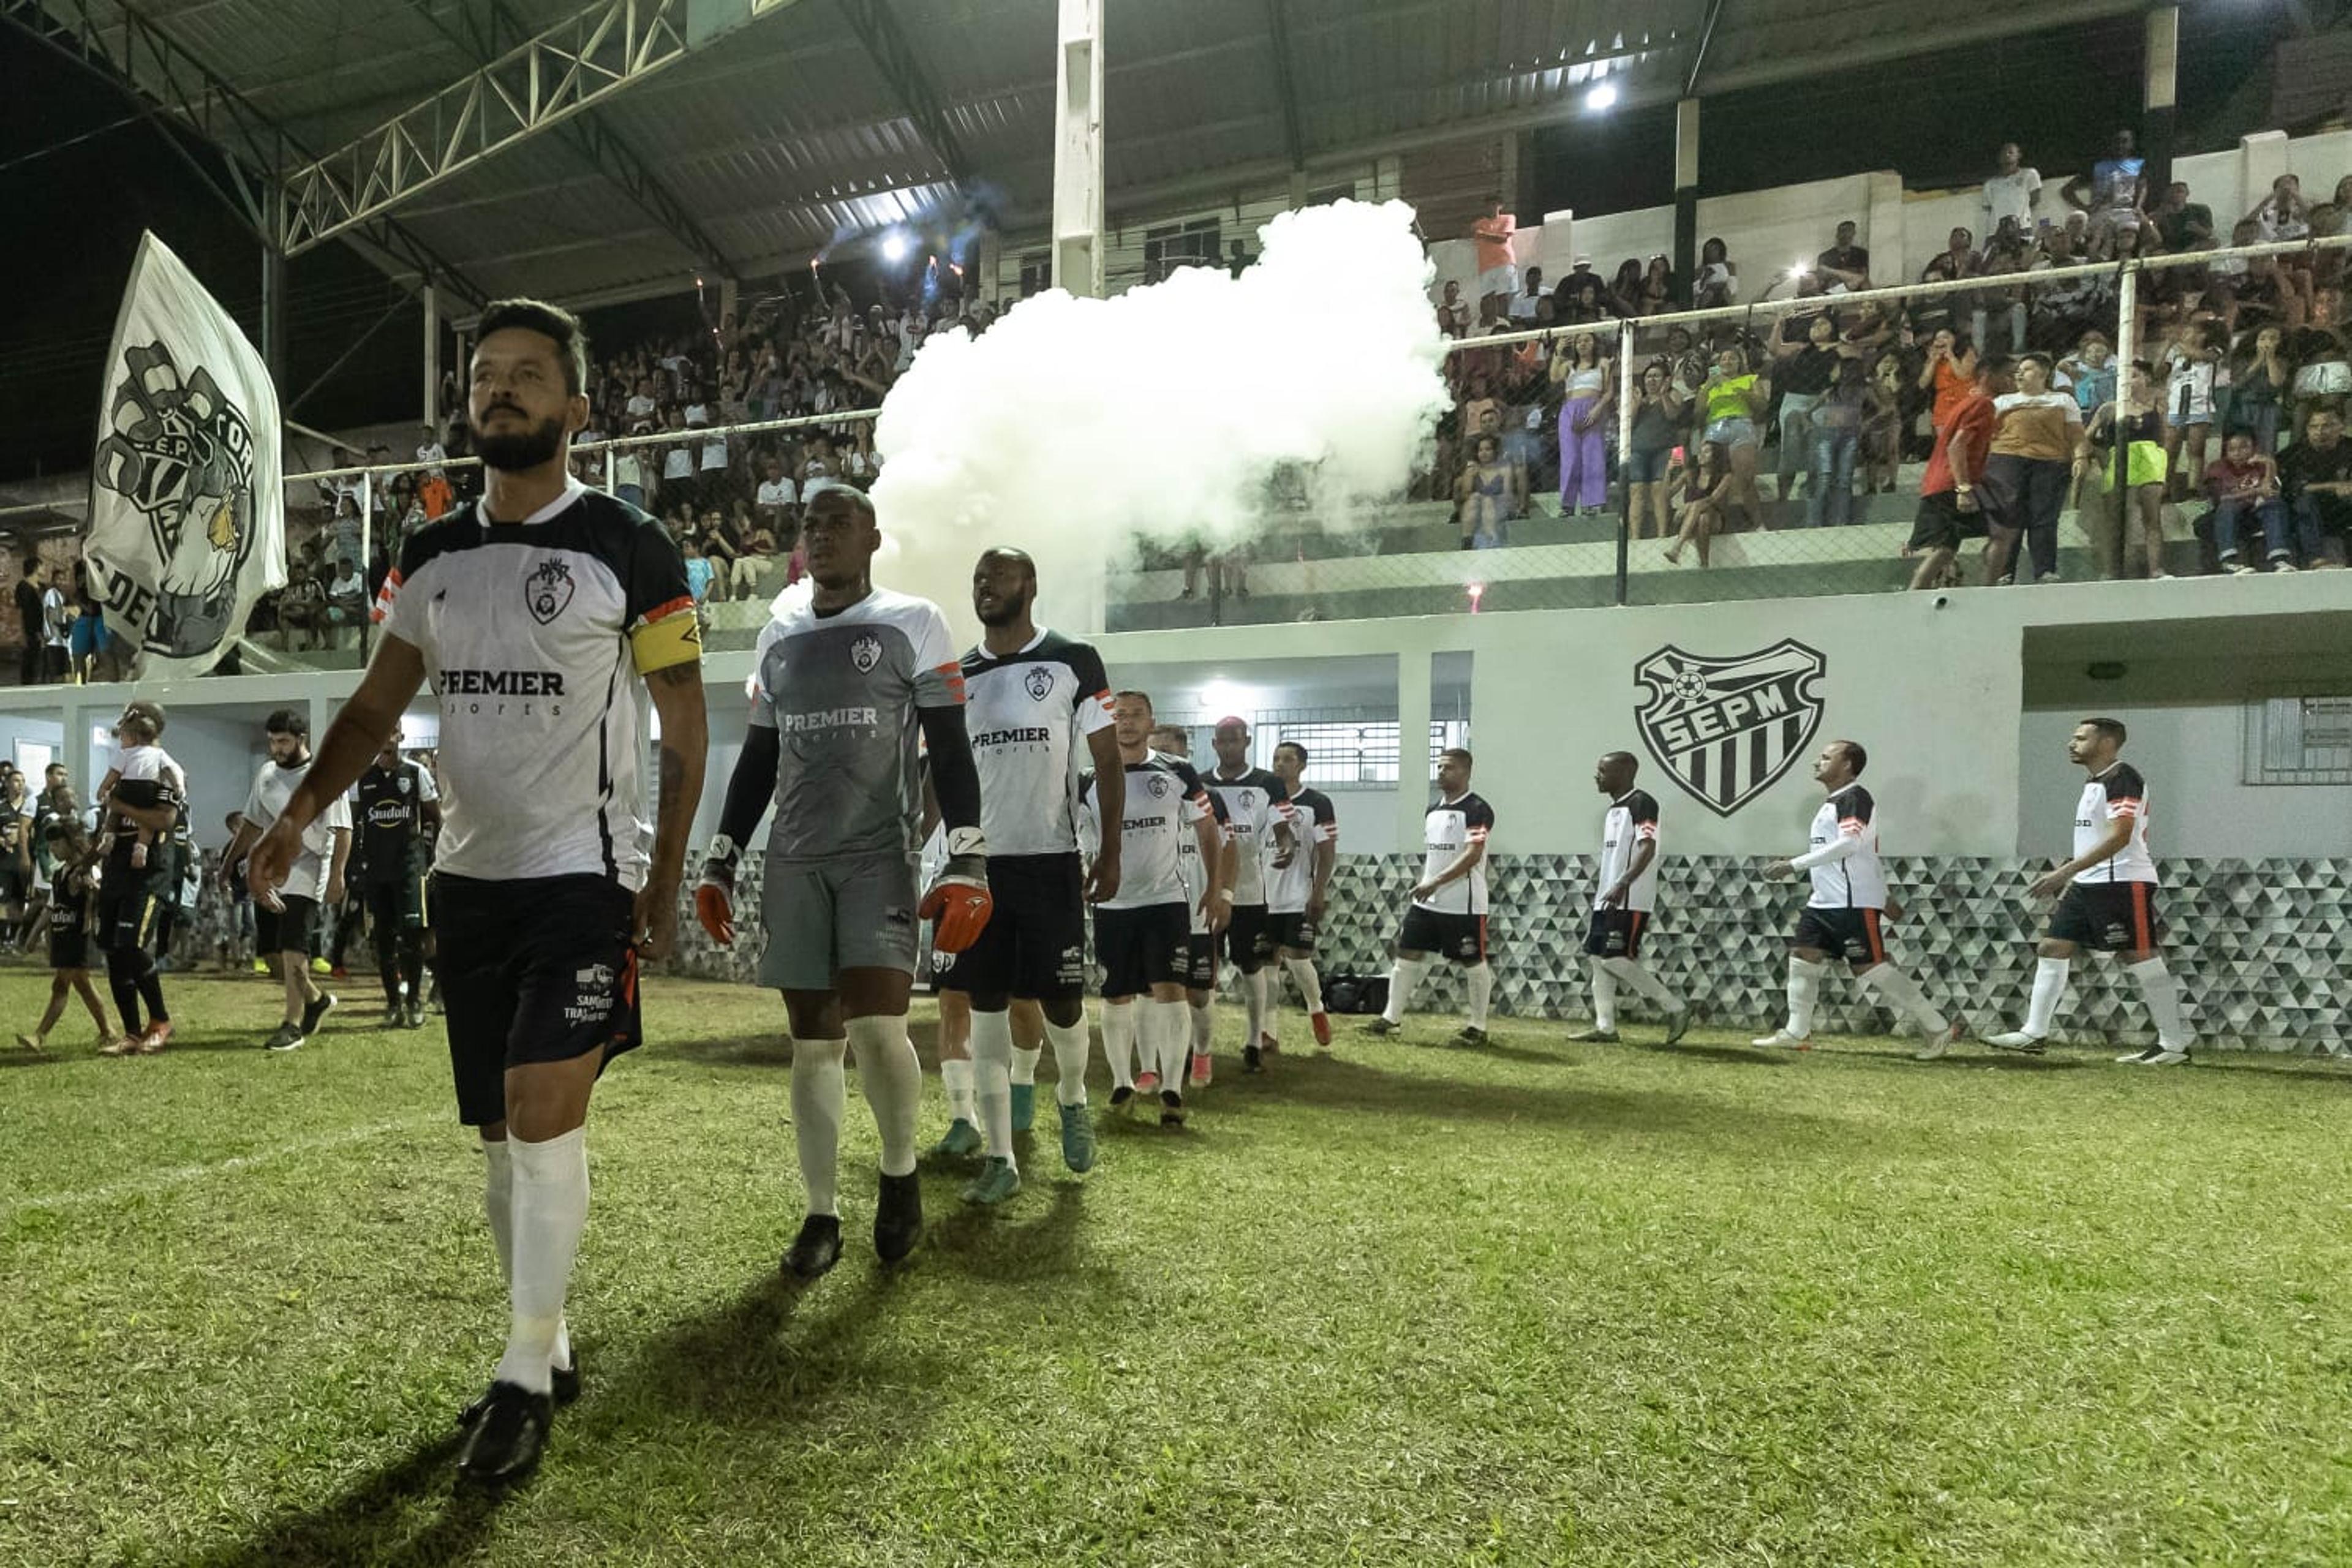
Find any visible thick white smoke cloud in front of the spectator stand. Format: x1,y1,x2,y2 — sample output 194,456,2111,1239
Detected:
873,202,1447,635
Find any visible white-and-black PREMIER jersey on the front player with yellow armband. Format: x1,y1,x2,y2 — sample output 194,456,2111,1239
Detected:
376,480,703,889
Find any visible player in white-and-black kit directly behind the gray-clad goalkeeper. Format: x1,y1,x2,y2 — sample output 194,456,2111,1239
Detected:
938,545,1126,1204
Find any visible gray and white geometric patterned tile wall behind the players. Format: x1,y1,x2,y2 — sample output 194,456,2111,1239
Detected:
654,856,2352,1051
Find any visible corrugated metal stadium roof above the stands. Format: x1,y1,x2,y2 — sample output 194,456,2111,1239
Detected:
37,0,2136,298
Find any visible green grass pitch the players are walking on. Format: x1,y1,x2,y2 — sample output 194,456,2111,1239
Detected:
0,971,2352,1568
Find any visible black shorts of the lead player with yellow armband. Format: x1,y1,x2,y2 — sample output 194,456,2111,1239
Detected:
433,872,644,1126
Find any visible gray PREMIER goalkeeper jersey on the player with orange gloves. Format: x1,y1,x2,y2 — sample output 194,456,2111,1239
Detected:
750,588,964,861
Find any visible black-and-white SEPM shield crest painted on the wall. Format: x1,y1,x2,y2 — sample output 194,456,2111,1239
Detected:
1632,637,1830,816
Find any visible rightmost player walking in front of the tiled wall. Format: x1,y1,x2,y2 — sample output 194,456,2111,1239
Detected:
1985,719,2190,1067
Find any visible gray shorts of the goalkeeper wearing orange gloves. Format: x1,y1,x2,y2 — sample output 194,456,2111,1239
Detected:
760,853,922,992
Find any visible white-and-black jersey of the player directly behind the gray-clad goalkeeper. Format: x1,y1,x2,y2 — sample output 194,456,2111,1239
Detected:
964,630,1110,858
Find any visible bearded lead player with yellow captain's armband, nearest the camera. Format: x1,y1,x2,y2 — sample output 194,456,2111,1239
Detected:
249,298,708,1483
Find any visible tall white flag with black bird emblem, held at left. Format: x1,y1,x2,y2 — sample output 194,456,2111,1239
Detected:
82,235,287,677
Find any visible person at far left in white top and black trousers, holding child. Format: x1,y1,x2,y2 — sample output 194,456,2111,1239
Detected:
89,698,188,1055
